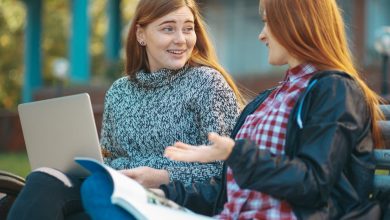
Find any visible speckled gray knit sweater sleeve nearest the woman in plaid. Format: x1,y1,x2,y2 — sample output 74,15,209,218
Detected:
167,68,239,184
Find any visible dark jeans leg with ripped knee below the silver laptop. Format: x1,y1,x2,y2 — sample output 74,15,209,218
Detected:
7,172,90,220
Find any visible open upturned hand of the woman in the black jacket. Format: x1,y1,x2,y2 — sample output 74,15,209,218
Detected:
164,133,234,163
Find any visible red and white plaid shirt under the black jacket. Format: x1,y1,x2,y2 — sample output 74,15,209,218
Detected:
216,64,316,220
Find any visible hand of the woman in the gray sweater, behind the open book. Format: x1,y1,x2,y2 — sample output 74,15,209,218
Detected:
120,167,169,188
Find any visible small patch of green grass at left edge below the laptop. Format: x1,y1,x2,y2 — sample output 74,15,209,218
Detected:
0,152,30,178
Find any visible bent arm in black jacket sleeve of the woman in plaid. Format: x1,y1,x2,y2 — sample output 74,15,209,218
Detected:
227,77,370,207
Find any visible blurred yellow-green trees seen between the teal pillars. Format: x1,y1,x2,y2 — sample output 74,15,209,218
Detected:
0,0,138,110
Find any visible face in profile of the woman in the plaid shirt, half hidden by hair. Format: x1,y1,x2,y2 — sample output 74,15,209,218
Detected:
259,13,301,68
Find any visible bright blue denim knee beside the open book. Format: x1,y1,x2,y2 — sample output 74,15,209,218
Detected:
81,172,135,220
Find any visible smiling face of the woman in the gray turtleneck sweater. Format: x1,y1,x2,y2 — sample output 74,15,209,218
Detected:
137,6,196,72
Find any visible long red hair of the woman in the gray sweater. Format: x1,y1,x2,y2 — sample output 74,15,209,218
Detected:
125,0,245,107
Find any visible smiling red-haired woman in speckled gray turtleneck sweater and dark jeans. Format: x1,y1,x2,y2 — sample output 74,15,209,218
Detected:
8,0,243,220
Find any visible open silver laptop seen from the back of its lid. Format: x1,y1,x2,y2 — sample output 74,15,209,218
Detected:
18,93,103,177
